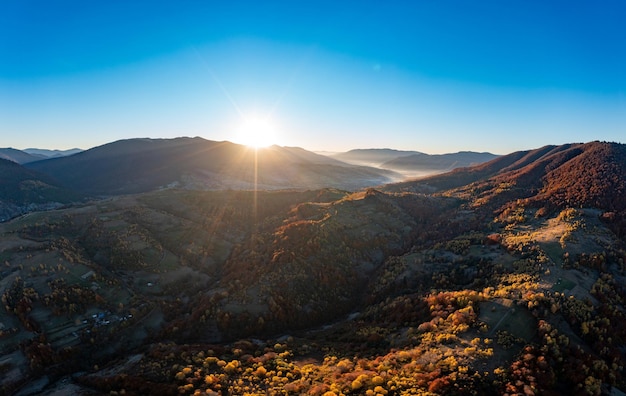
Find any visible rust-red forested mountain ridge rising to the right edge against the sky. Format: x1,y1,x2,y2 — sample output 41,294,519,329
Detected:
385,142,626,211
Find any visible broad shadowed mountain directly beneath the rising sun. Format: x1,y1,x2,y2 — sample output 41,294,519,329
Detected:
29,137,398,195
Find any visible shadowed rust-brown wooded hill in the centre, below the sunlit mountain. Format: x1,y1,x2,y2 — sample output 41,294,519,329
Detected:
214,189,458,331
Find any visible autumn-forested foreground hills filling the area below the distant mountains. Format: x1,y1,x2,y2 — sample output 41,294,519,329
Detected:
0,142,626,396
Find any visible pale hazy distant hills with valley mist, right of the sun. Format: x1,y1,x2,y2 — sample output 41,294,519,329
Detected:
332,149,498,176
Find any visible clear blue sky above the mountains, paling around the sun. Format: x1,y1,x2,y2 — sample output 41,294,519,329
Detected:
0,0,626,154
